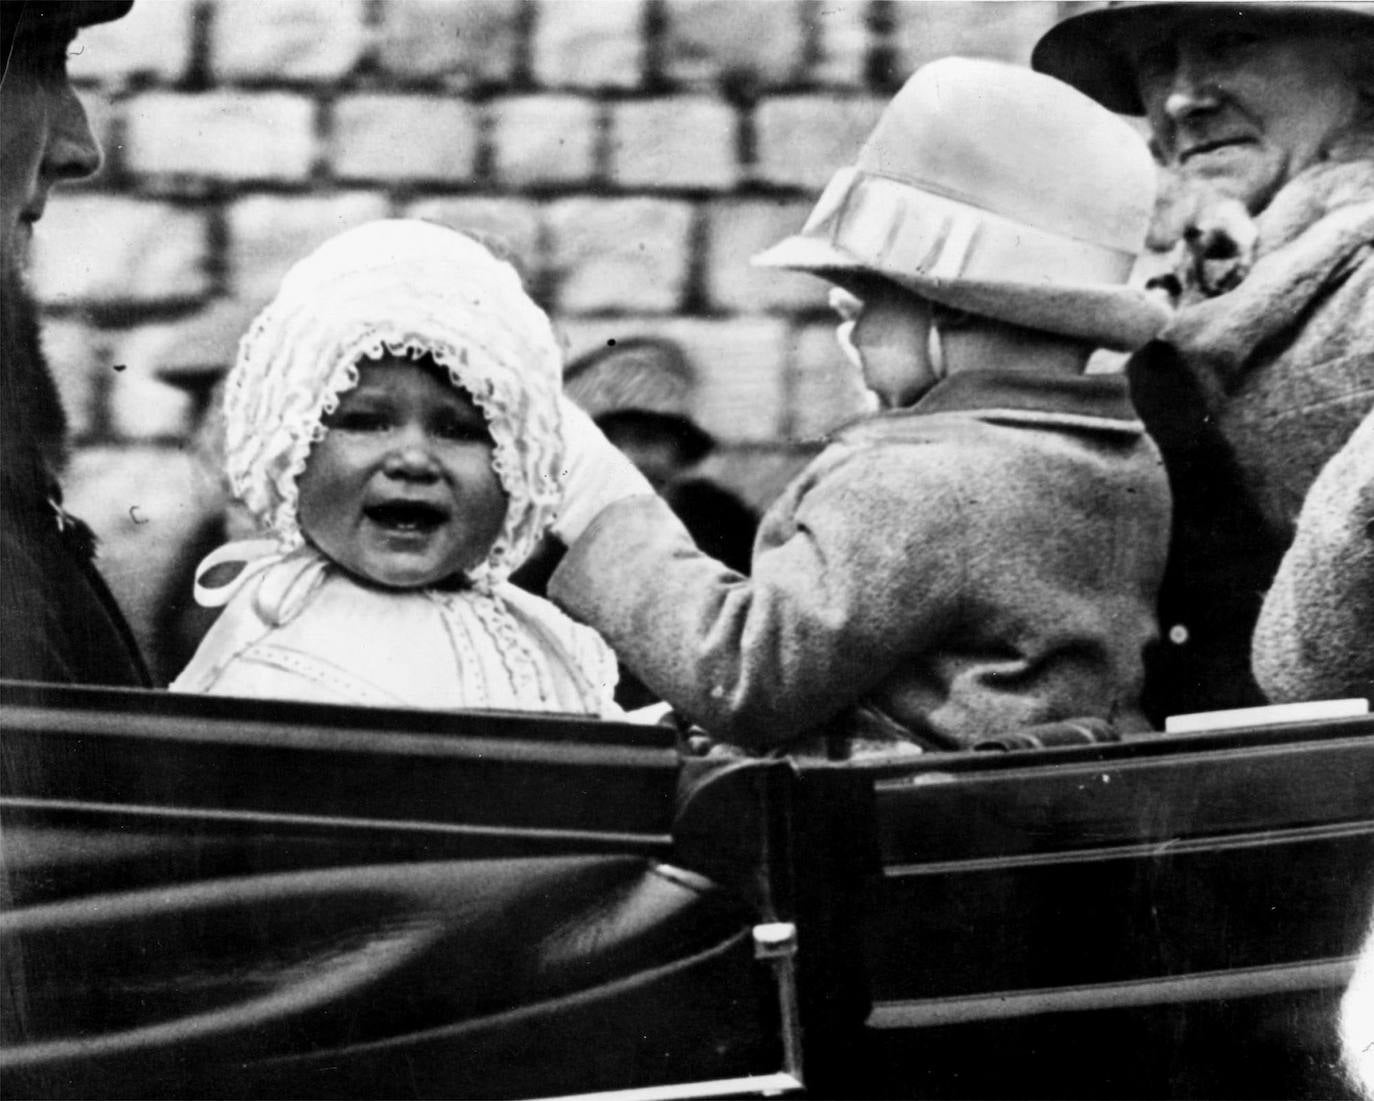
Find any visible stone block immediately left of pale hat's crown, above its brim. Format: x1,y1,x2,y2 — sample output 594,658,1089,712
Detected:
753,95,886,192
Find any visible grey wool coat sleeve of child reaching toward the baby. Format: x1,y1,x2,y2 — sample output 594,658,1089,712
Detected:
550,448,962,749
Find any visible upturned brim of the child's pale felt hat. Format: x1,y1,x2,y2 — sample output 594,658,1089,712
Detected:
753,236,1169,352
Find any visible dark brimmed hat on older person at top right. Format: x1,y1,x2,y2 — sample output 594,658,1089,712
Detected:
1031,0,1374,114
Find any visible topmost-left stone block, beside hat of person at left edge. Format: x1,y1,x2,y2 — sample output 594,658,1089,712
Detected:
66,0,196,84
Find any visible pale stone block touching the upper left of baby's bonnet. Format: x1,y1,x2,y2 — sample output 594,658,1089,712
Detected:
227,191,387,300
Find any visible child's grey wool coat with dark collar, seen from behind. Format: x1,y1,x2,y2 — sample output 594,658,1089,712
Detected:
550,371,1169,750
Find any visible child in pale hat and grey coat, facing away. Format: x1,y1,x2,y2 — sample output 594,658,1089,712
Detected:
550,59,1169,750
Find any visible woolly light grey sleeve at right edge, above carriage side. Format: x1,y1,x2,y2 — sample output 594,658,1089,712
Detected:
1253,414,1374,702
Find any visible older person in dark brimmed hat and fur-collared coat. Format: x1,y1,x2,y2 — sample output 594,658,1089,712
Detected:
1032,3,1374,722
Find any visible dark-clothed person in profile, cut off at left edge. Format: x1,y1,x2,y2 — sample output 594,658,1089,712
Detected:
0,0,148,686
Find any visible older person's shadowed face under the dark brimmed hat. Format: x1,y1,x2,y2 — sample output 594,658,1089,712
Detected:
1129,14,1374,213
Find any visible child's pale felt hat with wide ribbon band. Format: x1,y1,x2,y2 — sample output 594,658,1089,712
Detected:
754,58,1168,349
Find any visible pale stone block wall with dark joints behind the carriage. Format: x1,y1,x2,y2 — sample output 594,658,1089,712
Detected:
42,0,1066,673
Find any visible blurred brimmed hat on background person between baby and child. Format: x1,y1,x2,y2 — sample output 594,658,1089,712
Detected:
563,337,716,462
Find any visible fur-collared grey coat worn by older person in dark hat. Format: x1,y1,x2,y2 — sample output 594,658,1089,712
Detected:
1127,159,1374,722
